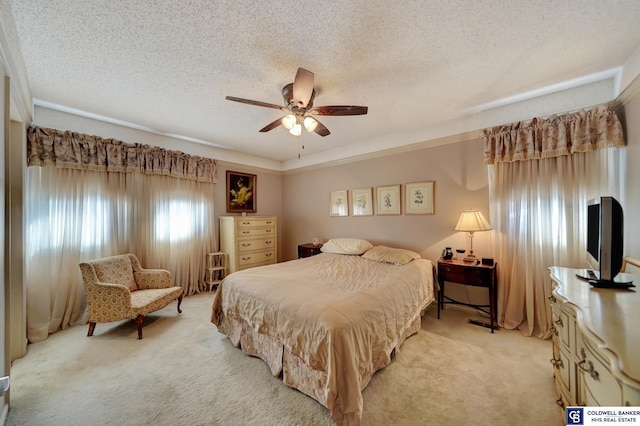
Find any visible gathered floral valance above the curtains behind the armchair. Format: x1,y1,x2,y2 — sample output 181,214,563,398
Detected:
27,126,218,183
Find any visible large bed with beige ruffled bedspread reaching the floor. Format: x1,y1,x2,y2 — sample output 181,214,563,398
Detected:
211,239,437,425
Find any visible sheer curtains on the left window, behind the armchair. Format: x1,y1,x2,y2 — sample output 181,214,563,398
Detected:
25,167,216,342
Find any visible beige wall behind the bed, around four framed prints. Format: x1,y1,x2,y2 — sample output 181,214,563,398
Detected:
281,139,491,261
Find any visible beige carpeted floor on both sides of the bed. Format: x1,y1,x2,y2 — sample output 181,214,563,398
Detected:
7,293,564,426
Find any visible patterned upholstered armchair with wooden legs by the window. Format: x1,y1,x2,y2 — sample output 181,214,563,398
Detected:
80,254,182,339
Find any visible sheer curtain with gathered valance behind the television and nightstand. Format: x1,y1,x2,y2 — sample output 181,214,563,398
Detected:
486,104,626,338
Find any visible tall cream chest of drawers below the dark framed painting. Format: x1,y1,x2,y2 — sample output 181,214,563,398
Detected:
220,216,278,274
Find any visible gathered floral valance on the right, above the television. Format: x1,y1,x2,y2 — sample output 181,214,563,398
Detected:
483,105,624,164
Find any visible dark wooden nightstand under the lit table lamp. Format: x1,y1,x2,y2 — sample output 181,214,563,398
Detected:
438,259,498,333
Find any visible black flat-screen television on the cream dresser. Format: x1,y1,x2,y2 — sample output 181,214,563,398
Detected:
586,197,632,287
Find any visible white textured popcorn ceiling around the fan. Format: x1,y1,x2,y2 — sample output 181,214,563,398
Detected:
9,0,640,167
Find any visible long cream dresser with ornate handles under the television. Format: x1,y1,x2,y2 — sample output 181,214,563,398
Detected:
549,267,640,407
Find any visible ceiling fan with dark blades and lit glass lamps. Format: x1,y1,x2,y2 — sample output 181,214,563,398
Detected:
226,68,368,136
